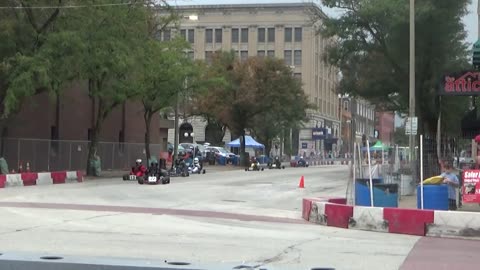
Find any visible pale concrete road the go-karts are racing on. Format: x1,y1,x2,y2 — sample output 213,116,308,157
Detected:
0,166,476,269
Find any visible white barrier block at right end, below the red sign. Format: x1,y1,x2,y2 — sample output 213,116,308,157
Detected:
427,211,480,238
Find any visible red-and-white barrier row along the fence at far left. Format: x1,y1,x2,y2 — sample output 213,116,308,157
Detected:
0,171,83,188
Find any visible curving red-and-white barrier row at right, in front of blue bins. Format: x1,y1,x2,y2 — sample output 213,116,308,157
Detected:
302,198,480,238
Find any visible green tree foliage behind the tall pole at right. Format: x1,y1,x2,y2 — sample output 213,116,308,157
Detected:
315,0,469,134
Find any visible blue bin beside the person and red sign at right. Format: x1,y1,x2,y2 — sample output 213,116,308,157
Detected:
417,185,448,210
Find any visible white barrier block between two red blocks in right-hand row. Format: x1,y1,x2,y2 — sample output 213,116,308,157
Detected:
348,206,388,232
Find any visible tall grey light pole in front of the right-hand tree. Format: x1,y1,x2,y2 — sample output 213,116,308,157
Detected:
408,0,415,158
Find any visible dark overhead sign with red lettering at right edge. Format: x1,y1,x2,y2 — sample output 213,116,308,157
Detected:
438,71,480,96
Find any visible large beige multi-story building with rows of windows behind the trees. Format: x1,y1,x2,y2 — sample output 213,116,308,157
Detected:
167,3,340,153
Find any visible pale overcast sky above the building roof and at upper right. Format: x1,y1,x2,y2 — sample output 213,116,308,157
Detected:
170,0,478,43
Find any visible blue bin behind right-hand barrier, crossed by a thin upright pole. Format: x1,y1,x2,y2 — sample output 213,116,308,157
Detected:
355,179,398,207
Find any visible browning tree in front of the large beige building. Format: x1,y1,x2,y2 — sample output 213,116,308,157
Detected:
199,52,307,164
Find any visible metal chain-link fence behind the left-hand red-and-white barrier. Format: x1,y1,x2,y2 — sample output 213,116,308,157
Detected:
1,138,163,172
